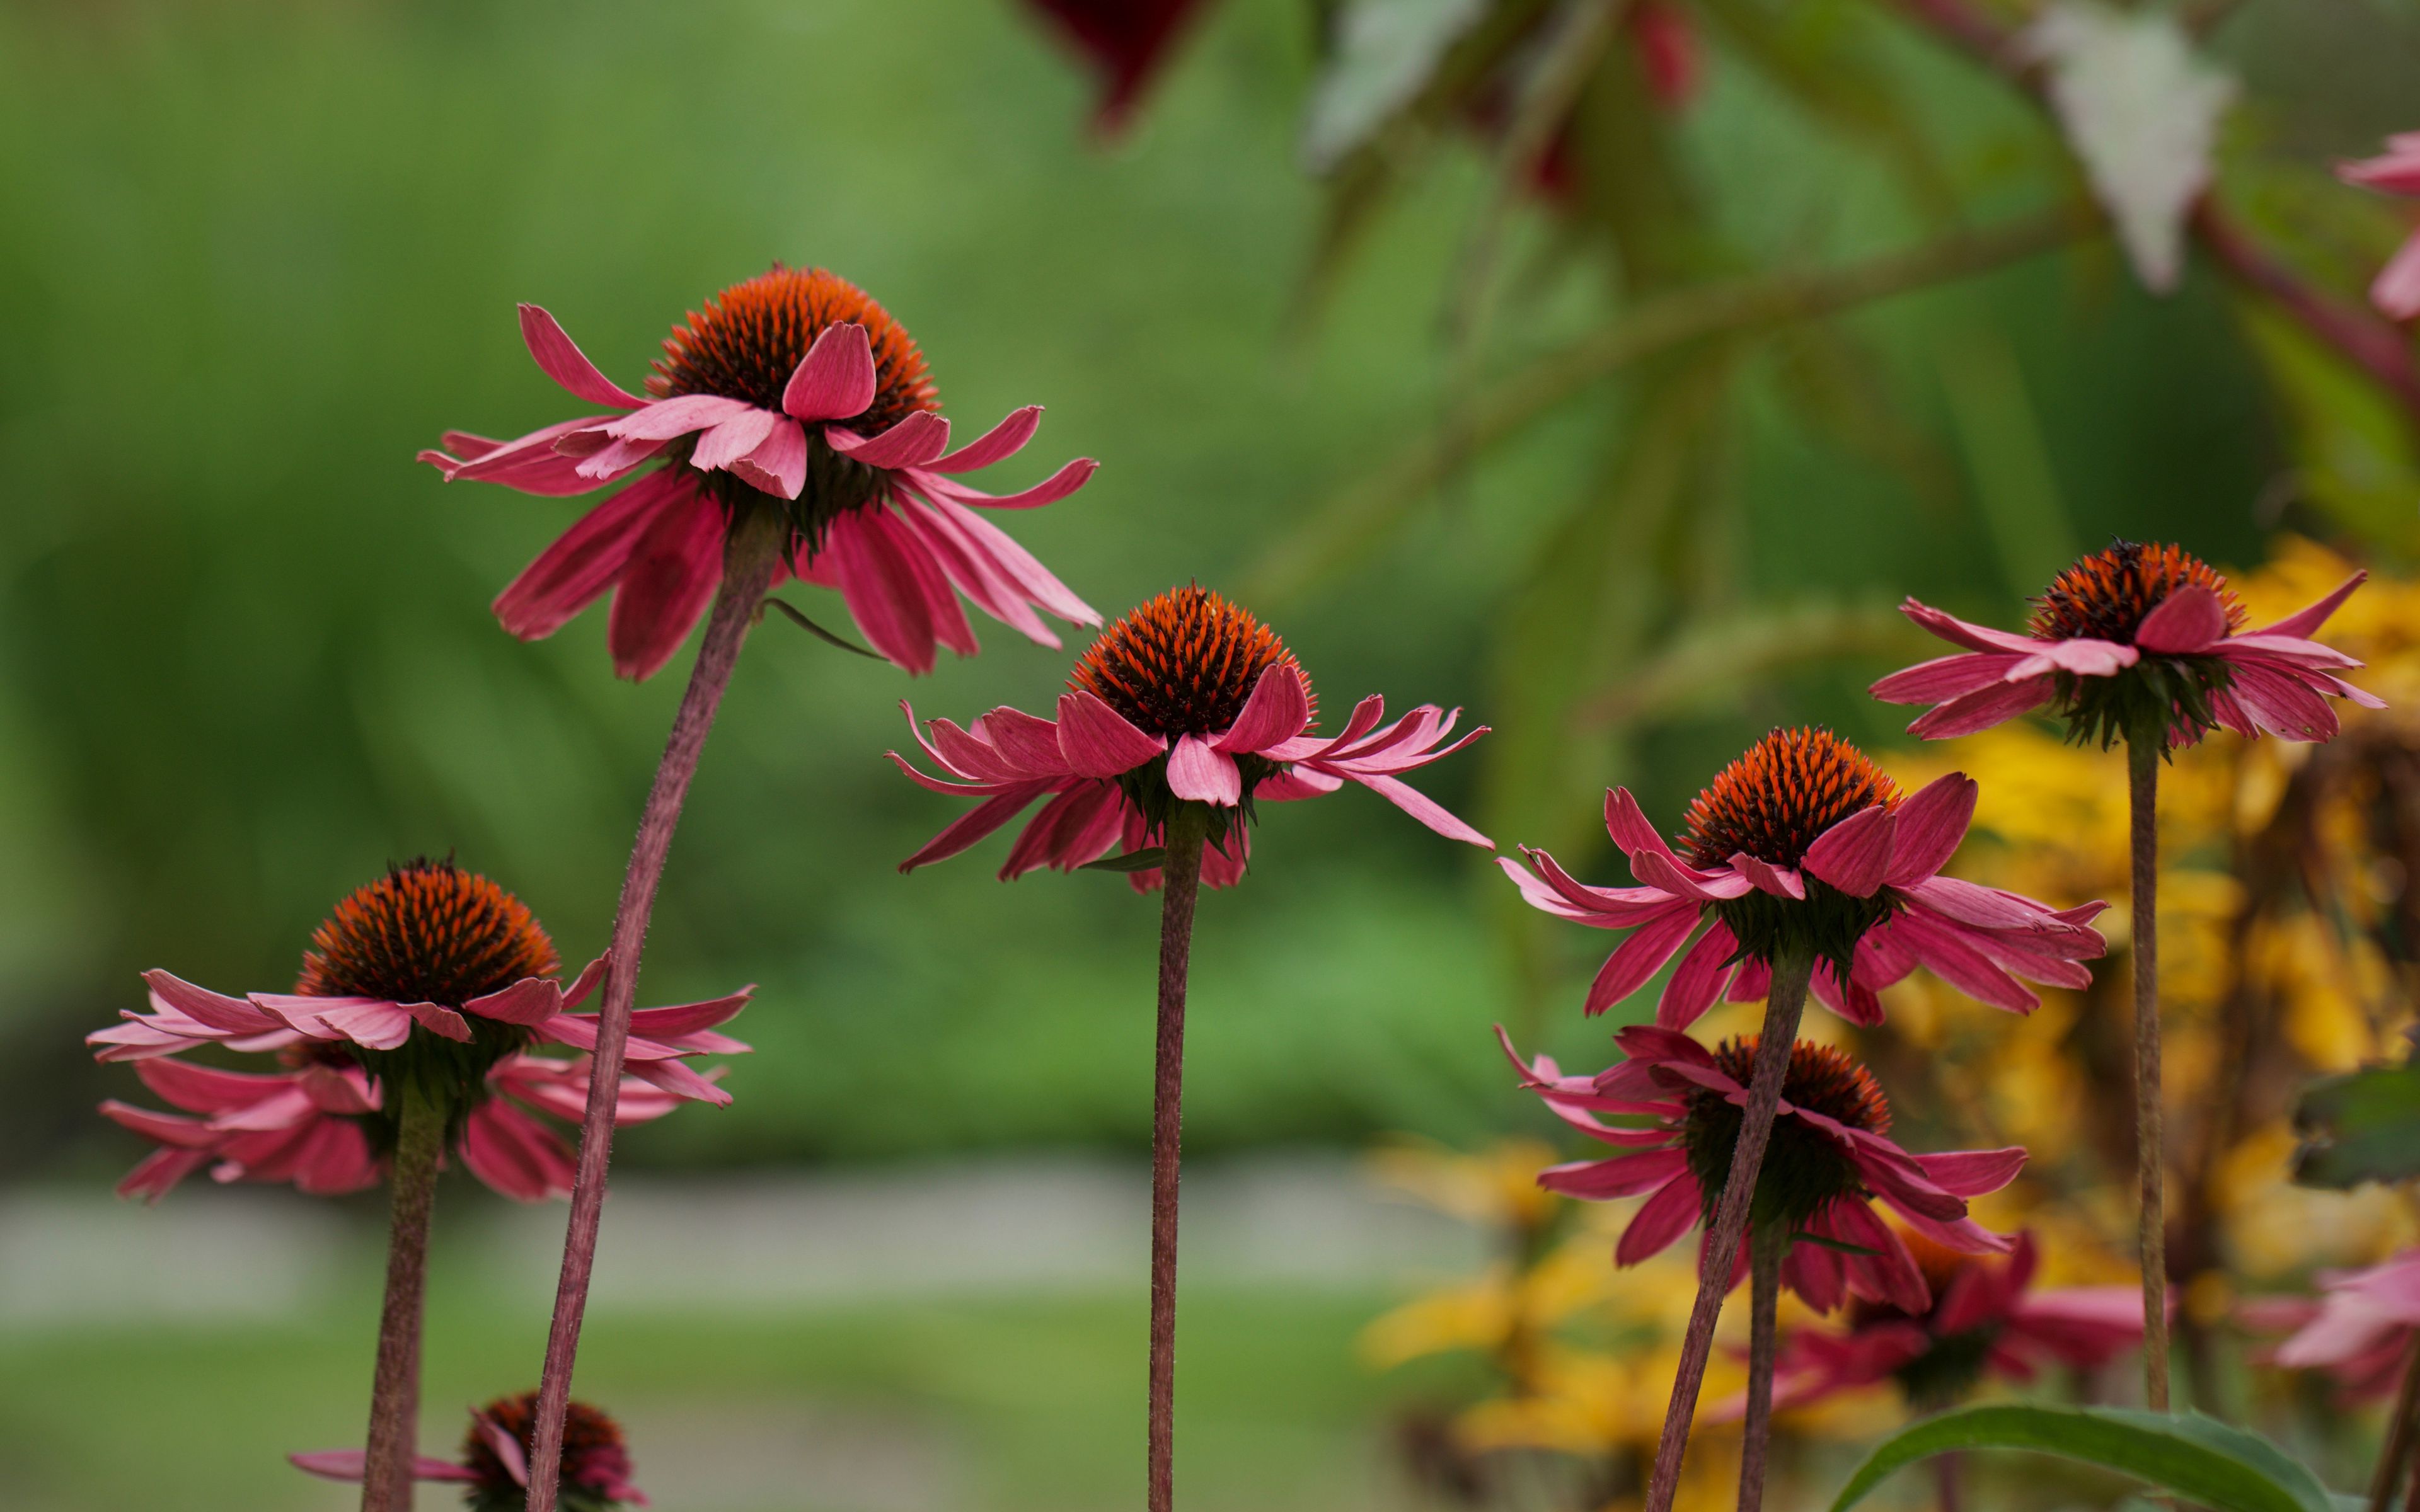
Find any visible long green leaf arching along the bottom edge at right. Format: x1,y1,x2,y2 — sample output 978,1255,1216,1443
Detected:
1832,1403,2336,1512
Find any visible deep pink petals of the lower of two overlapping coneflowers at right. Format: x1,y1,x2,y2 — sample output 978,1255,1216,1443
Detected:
1495,1023,2025,1314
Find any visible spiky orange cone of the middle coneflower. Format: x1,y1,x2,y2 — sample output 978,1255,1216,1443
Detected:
1067,588,1317,740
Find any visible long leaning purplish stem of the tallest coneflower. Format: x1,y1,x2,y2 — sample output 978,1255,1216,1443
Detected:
527,508,786,1512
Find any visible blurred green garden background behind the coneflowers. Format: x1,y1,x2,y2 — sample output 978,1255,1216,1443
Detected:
14,0,2420,1512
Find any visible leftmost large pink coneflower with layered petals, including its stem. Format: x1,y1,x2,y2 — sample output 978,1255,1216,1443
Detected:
89,859,748,1512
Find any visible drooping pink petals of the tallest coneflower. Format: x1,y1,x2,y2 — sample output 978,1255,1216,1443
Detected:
421,289,1101,680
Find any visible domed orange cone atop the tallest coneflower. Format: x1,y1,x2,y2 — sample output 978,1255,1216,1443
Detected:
646,264,942,435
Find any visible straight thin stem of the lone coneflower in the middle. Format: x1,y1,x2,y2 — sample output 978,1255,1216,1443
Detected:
1147,803,1207,1512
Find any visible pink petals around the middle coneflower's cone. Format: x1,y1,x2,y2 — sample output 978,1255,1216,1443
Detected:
888,663,1493,890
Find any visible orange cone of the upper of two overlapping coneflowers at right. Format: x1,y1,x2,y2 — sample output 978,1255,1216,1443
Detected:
1680,728,1899,866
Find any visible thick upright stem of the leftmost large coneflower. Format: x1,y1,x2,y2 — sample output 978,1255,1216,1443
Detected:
360,1077,446,1512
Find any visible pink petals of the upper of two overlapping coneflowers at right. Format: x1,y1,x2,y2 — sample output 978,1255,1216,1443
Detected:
1495,772,2108,1028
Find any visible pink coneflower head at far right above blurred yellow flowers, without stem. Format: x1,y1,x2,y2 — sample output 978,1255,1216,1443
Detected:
1873,542,2383,752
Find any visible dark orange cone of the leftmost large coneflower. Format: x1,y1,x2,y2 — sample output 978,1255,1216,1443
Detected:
295,859,562,1009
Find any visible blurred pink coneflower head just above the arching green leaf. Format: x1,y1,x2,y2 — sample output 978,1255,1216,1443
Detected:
1774,1232,2141,1411
